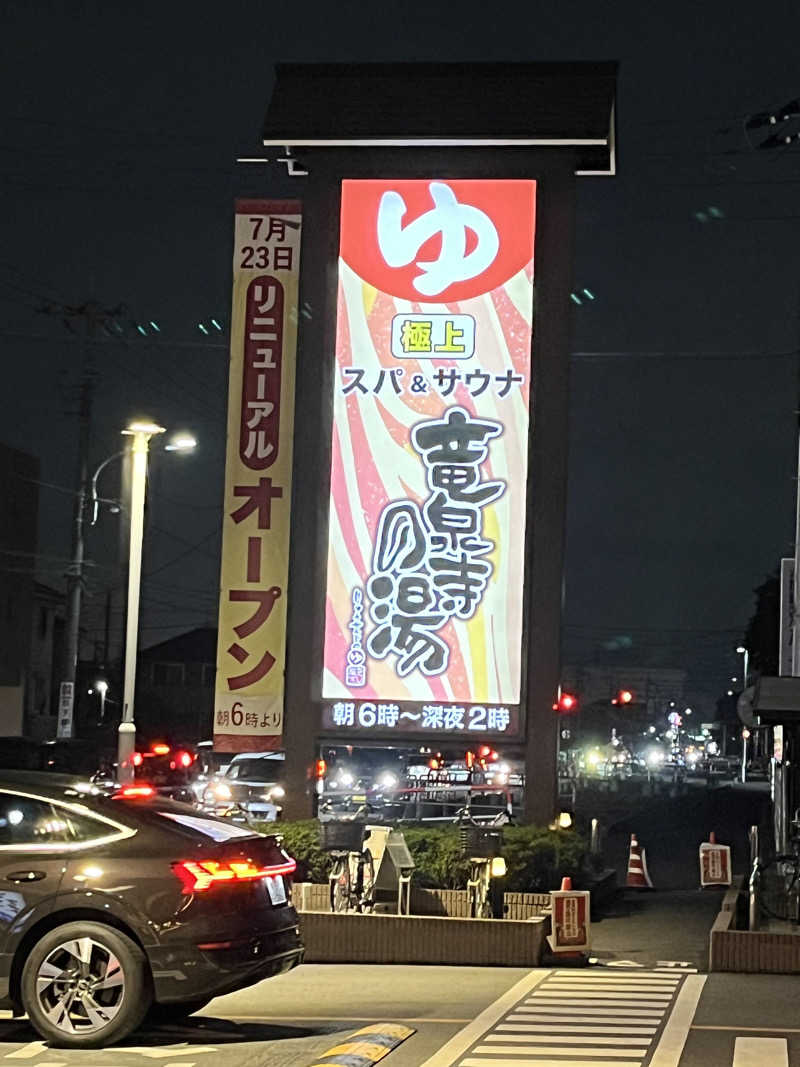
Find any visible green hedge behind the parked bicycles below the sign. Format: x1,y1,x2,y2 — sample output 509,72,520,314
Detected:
259,819,587,893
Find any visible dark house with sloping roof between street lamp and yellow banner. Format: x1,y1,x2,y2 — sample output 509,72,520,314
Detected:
134,626,217,743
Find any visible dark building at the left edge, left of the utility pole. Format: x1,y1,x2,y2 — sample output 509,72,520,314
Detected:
0,444,39,737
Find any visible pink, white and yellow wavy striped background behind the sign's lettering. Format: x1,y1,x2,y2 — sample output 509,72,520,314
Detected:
322,187,533,704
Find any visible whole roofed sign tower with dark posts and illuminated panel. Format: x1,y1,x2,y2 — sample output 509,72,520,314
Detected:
247,64,617,822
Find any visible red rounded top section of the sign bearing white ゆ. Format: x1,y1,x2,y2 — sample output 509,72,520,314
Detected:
340,178,535,304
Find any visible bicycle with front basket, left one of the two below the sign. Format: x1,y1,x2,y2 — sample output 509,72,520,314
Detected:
320,805,375,913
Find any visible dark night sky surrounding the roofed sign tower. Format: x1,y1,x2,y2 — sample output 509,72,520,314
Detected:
0,0,800,708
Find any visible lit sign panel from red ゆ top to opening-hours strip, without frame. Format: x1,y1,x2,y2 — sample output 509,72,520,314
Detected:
322,178,537,736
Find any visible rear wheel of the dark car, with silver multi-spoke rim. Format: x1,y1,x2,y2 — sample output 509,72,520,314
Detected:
20,923,153,1049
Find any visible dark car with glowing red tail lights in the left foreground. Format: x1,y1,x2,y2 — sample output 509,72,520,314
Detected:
0,771,303,1048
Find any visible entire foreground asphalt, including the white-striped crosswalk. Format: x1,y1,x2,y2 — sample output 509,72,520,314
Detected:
0,961,800,1067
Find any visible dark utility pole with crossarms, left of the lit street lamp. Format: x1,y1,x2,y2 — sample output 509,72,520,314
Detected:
42,301,124,737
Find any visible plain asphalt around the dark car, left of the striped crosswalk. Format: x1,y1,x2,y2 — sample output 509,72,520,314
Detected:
0,964,529,1067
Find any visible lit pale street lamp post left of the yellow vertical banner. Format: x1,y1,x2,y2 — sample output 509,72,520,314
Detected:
116,421,196,784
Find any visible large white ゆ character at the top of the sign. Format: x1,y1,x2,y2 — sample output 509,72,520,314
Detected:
378,181,500,297
